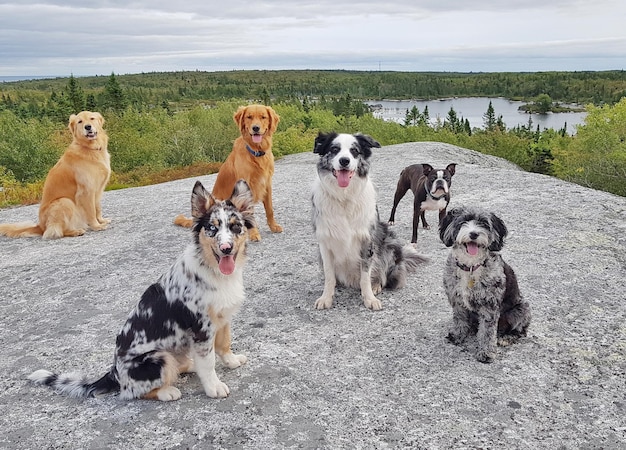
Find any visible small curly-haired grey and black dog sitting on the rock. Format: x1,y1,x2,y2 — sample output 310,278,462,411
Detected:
439,207,531,363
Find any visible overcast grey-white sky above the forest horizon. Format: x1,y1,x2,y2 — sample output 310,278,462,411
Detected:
0,0,626,76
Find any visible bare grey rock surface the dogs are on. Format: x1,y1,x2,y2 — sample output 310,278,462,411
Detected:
0,143,626,449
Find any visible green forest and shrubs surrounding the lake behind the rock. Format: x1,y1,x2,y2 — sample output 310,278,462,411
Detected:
0,71,626,207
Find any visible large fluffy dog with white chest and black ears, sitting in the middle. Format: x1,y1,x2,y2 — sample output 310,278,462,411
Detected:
312,133,425,310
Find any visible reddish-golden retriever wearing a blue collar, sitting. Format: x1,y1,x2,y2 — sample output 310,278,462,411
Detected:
174,105,283,241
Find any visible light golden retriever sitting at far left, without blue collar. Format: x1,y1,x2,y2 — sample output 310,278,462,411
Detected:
0,111,111,239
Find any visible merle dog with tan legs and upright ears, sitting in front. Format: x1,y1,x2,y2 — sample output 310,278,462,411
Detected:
29,180,256,401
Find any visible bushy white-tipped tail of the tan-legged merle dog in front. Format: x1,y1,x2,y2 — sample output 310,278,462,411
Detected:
28,369,120,398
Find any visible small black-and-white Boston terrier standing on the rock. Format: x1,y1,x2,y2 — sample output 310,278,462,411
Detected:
389,163,456,243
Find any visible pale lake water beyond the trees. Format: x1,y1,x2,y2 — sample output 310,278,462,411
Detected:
364,97,587,134
